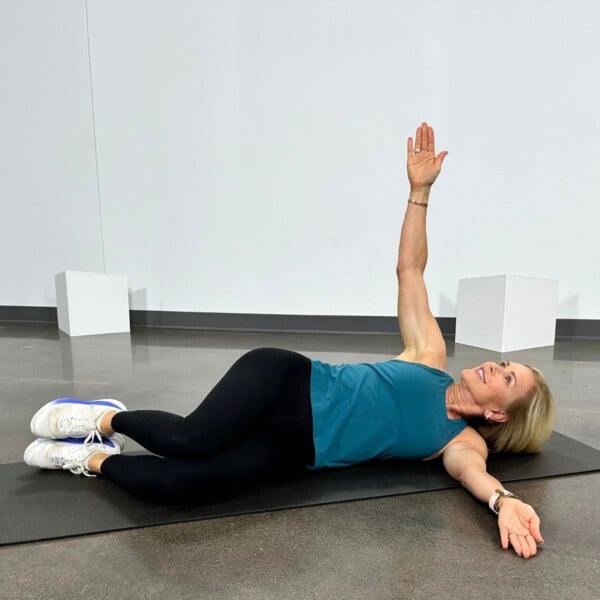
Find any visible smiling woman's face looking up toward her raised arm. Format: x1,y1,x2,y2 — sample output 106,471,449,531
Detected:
461,360,535,418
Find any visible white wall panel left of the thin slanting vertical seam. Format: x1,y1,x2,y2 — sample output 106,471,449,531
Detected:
0,0,103,306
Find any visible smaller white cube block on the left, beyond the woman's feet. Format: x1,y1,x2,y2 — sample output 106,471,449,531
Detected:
55,271,130,336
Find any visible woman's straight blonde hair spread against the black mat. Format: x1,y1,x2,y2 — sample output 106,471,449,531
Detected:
472,365,554,453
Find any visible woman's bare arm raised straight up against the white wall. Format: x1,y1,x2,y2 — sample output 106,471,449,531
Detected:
396,123,448,369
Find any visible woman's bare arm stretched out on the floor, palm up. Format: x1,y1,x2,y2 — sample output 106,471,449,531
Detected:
443,439,544,558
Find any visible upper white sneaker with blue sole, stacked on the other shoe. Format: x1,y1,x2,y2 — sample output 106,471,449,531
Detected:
31,398,127,442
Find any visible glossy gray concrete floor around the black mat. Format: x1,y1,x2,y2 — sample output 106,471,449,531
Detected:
0,323,600,600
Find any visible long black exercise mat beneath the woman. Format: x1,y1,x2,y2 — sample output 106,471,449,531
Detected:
0,432,600,545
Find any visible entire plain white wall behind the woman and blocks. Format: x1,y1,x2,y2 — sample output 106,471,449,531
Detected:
0,0,600,319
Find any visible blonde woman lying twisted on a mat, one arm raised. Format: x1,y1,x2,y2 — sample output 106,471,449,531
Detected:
24,123,553,557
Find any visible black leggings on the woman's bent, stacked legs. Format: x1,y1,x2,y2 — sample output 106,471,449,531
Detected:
102,348,315,503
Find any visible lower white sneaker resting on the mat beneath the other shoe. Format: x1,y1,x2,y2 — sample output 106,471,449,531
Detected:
23,438,121,477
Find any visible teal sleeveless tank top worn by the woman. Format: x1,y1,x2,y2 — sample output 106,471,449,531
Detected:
309,359,467,469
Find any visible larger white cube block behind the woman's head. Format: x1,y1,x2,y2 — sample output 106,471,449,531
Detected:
455,275,558,352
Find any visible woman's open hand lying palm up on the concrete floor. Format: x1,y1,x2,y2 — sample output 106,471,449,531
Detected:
498,498,544,558
